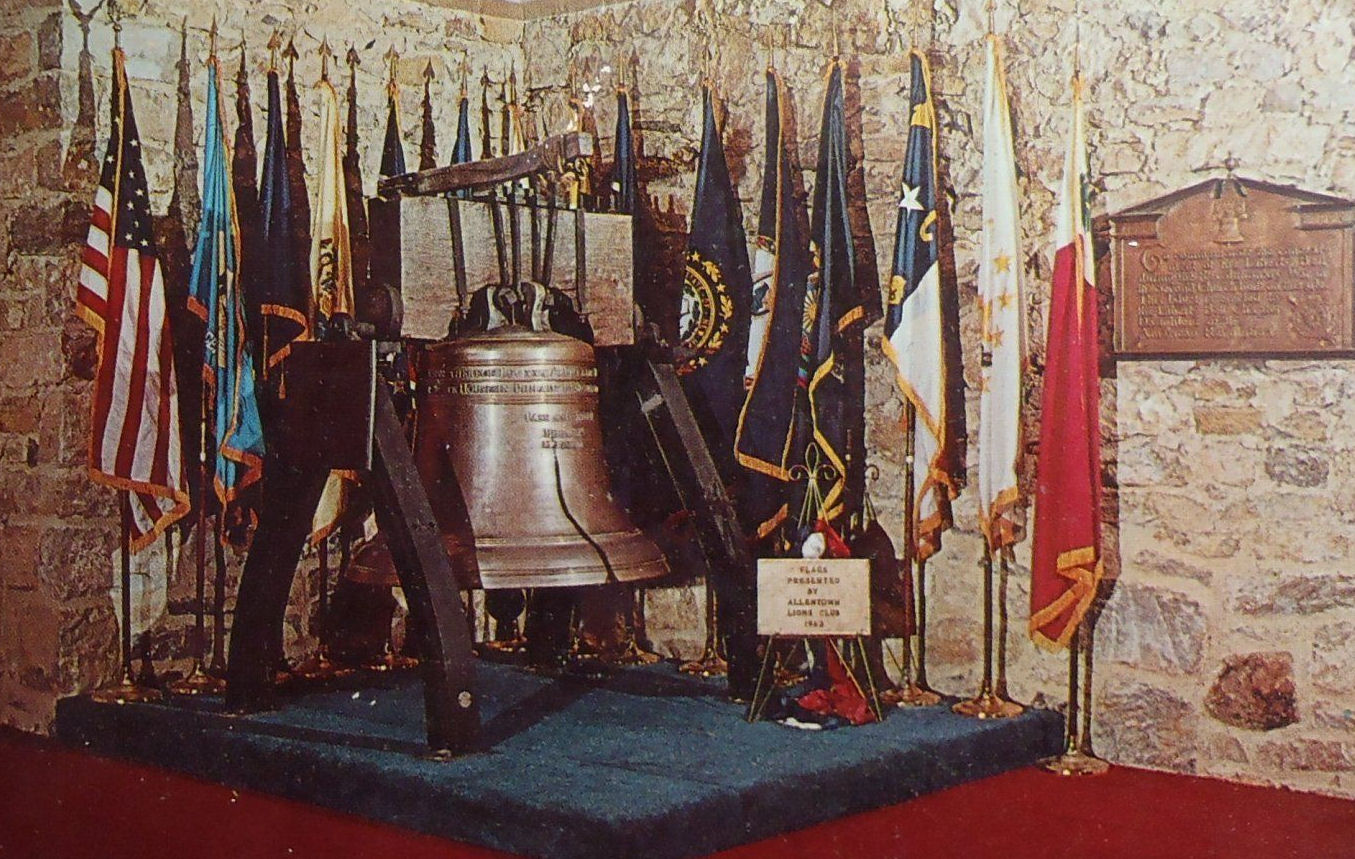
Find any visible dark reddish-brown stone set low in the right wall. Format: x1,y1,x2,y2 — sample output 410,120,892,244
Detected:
1205,650,1298,730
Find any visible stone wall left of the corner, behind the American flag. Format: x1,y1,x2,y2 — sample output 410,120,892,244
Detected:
0,0,523,730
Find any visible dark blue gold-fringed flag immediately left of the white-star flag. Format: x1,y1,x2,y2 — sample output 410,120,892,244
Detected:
794,58,866,530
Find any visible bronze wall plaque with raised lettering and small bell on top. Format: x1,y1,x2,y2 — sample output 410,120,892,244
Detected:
1110,176,1355,358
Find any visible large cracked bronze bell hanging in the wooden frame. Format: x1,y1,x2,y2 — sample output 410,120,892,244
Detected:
415,325,668,588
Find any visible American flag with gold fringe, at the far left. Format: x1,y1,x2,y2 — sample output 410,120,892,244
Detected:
76,50,188,551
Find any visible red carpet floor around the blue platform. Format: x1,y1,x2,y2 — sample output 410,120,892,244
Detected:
0,730,1355,859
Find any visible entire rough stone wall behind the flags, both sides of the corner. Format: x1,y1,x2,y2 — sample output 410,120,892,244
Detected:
0,0,1355,795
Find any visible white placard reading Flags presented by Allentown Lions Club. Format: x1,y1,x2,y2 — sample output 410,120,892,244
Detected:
757,558,870,637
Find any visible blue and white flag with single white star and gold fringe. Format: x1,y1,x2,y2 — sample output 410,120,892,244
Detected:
881,50,958,560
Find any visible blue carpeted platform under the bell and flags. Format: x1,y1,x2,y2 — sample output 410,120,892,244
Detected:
57,663,1062,859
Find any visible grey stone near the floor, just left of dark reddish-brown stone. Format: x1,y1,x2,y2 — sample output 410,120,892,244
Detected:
1096,683,1198,772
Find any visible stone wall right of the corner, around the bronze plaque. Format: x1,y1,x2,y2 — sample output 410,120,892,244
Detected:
524,0,1355,795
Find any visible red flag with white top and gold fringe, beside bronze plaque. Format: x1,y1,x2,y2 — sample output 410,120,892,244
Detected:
1030,75,1102,649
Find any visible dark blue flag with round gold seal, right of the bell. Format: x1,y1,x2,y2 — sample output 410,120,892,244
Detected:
679,85,752,482
